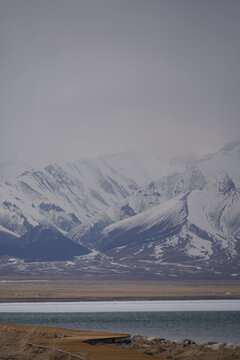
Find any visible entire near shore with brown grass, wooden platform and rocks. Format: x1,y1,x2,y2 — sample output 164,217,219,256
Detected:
0,324,240,360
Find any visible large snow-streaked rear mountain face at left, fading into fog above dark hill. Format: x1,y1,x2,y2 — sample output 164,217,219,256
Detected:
0,151,188,234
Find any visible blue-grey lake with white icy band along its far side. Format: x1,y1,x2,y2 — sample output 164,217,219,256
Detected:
0,300,240,343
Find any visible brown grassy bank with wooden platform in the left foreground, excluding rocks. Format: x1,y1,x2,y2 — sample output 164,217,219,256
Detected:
0,324,155,360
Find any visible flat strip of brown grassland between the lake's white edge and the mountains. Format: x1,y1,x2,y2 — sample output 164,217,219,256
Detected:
0,280,240,302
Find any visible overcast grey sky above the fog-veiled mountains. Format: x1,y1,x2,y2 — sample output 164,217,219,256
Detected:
0,0,240,163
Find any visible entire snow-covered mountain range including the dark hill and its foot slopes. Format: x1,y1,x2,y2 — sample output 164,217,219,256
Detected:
0,142,240,279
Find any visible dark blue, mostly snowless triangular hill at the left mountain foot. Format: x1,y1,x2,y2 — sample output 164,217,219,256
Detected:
0,226,90,262
